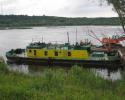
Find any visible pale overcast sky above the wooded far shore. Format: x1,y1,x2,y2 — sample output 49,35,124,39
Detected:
0,0,117,17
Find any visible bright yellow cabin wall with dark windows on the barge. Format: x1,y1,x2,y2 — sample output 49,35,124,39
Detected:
26,48,89,59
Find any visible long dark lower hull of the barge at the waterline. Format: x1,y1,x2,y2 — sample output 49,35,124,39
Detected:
7,57,122,68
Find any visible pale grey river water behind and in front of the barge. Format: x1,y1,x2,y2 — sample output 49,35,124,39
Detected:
0,26,124,80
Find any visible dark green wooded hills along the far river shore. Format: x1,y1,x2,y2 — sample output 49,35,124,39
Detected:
0,15,120,29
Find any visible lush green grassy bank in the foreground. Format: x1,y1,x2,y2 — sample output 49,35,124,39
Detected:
0,64,125,100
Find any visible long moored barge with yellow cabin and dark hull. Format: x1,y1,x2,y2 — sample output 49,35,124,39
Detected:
6,42,121,68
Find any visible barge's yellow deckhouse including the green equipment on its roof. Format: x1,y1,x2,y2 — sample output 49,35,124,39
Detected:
26,42,89,59
